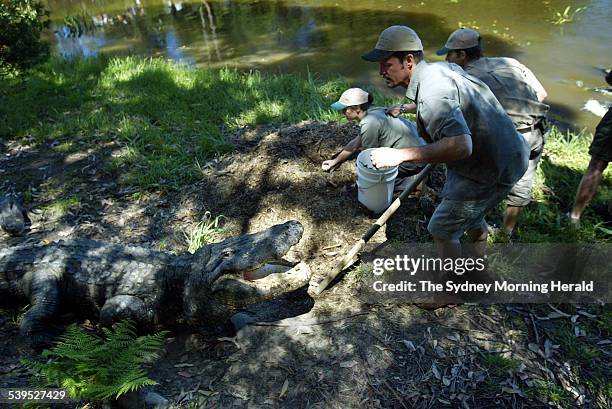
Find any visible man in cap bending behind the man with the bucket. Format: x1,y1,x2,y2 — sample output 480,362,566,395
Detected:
436,28,549,235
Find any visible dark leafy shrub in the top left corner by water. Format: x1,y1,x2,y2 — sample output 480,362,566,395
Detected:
0,0,49,76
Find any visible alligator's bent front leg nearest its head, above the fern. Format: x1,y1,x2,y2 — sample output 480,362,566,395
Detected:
100,295,154,327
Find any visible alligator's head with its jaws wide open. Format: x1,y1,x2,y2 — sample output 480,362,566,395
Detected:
183,221,310,323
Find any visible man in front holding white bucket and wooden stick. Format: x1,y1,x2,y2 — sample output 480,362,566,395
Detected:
362,26,529,270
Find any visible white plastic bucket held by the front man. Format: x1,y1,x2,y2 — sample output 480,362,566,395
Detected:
357,149,397,213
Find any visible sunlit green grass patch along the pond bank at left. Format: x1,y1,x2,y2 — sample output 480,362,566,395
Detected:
0,57,364,189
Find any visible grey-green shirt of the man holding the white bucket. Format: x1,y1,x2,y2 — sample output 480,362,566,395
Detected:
406,61,529,200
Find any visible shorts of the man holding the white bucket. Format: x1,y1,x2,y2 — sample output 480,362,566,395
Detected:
427,185,511,240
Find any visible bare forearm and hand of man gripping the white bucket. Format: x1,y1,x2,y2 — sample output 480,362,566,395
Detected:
372,135,472,168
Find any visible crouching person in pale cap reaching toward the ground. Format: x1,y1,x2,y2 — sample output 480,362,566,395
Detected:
321,88,425,189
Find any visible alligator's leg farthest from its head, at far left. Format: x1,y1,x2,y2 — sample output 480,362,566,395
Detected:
19,269,59,348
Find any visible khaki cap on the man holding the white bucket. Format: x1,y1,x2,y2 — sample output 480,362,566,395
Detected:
361,26,423,62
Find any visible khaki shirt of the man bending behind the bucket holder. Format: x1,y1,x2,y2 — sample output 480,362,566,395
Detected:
464,57,550,129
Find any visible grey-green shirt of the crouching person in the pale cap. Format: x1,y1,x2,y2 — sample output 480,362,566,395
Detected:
359,107,425,171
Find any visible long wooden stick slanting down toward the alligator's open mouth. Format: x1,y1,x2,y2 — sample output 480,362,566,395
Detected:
314,164,433,294
